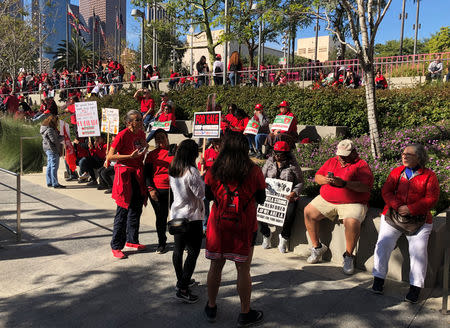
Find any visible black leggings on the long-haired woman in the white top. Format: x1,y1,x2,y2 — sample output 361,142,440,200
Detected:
172,220,203,290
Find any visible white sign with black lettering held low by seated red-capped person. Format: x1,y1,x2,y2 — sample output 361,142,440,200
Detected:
256,178,292,227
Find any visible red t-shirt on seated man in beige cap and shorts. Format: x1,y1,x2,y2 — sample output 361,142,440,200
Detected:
316,156,373,204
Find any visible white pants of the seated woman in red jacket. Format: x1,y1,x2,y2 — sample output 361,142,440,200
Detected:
372,215,433,288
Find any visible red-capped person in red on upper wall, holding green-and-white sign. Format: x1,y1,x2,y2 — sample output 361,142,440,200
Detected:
266,100,298,156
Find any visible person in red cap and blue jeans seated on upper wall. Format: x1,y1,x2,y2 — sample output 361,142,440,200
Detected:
244,104,270,159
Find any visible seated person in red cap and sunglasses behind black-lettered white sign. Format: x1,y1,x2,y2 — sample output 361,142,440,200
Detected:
259,141,304,253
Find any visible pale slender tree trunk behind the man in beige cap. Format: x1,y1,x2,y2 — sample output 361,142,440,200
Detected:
363,66,381,158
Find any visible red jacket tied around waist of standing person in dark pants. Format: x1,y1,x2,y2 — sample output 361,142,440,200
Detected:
111,164,147,209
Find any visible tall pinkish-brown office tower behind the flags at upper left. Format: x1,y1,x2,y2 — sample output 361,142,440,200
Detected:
79,0,127,55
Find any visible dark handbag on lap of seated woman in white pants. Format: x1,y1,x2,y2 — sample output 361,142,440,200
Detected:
384,172,427,236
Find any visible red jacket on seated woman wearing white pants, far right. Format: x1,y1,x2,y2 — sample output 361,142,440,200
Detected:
381,165,439,223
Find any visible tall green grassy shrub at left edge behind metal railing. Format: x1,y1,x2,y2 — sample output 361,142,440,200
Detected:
0,116,45,173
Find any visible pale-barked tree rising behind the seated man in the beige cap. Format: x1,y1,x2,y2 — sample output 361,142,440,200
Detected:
309,0,392,158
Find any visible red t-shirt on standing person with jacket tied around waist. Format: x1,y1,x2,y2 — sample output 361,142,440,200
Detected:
111,128,146,168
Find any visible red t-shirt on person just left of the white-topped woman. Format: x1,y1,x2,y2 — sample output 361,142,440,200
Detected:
145,148,173,189
